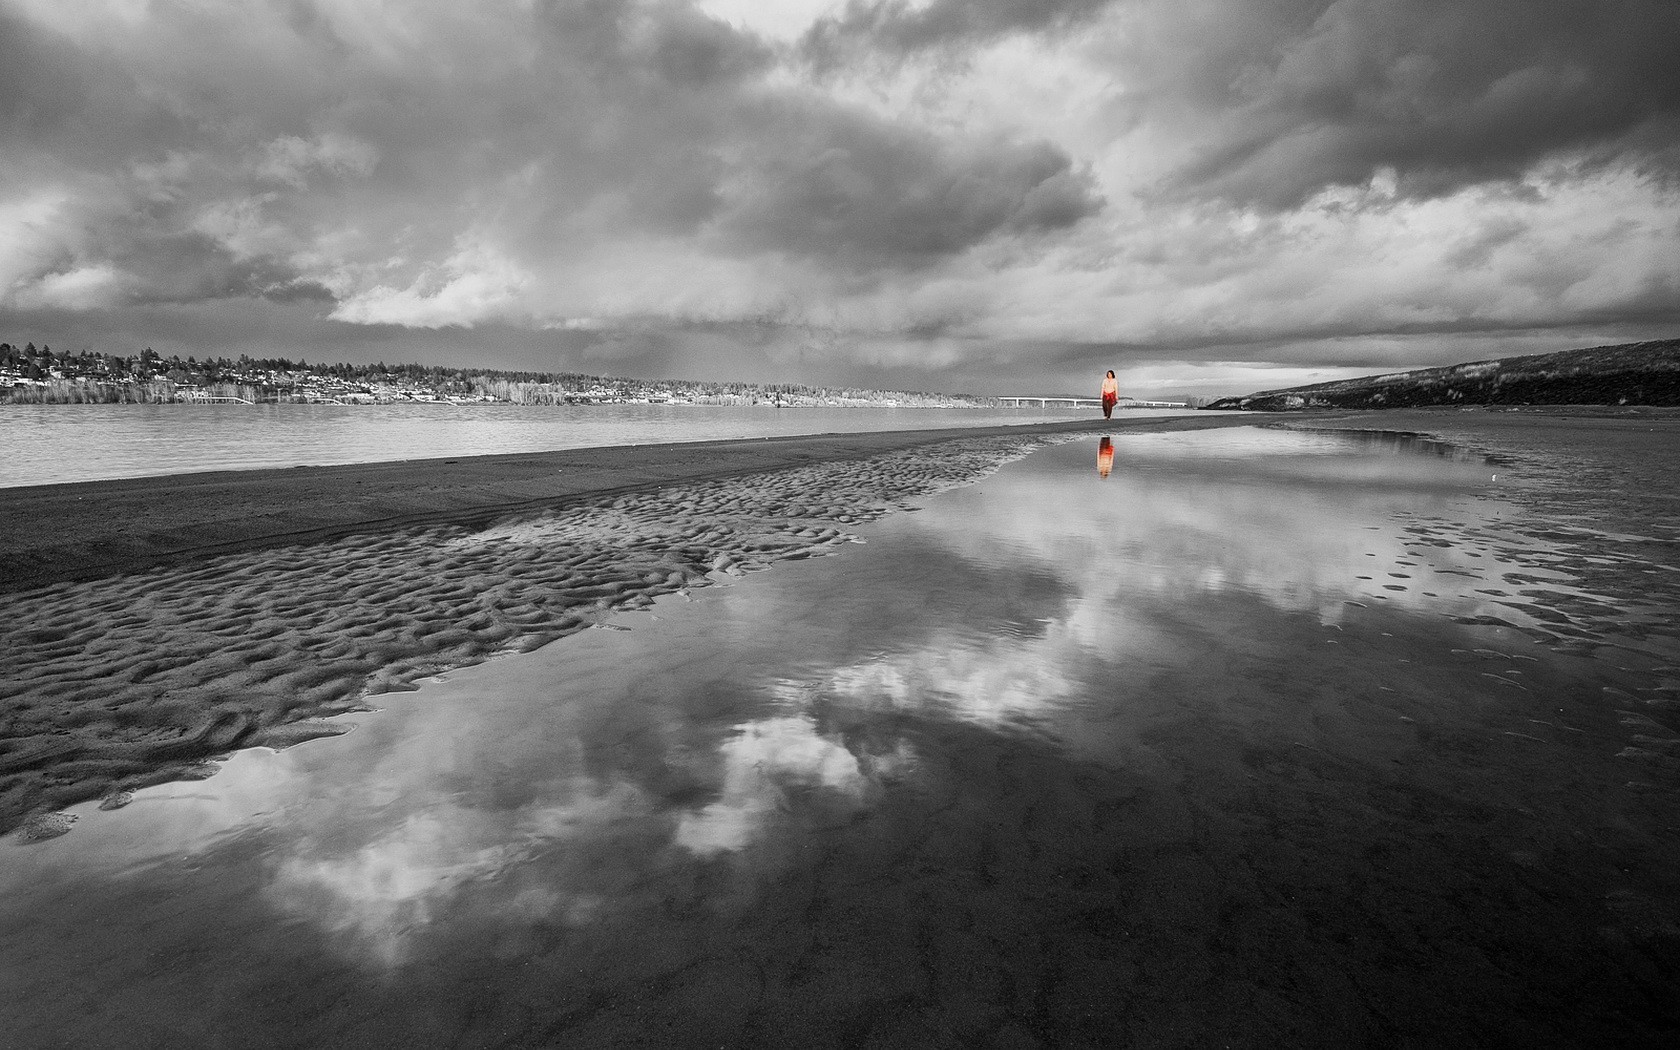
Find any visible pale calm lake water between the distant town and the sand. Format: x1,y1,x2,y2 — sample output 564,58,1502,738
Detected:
0,405,1142,487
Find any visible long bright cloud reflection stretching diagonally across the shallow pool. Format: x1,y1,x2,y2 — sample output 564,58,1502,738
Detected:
0,421,1494,969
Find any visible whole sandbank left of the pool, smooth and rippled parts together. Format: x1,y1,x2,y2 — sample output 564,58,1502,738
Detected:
0,415,1252,838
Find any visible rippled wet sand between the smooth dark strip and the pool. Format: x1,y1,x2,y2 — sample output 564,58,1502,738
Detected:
0,426,1115,838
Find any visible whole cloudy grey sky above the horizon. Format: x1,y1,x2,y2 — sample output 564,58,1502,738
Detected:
0,0,1680,396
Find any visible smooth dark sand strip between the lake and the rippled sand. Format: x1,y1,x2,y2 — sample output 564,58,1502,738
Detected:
0,413,1255,593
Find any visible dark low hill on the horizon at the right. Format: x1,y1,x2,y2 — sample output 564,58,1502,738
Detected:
1208,339,1680,412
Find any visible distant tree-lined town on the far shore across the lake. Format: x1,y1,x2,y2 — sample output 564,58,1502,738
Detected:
0,343,1209,408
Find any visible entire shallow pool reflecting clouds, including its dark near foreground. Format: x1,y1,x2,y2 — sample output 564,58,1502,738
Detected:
0,430,1680,1047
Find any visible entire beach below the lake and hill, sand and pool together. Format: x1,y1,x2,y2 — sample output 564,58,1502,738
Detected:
0,410,1680,1047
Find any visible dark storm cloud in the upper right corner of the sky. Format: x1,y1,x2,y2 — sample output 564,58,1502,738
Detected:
1149,0,1680,208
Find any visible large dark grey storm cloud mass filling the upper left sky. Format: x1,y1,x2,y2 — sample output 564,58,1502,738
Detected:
0,0,1100,323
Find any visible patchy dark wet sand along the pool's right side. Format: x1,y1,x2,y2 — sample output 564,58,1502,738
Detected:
1283,413,1680,782
